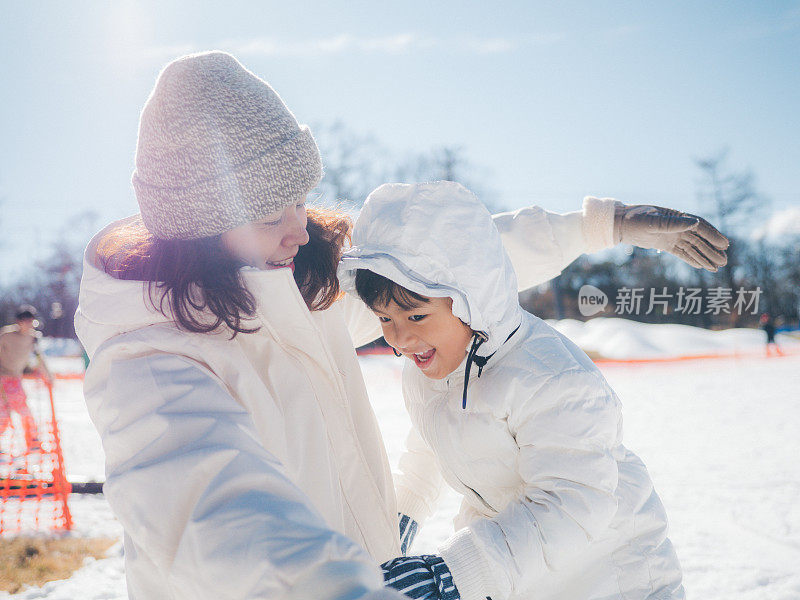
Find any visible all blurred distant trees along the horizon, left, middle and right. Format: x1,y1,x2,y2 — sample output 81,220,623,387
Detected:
0,127,800,337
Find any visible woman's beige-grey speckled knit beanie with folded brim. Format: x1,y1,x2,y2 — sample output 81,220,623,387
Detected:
133,52,322,240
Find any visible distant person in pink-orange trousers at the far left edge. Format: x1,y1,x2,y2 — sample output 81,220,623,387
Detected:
0,305,52,451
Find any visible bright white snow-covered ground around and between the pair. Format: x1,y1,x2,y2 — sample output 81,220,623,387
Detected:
0,319,800,600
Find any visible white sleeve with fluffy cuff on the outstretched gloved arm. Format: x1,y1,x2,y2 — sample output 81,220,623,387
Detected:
493,197,615,290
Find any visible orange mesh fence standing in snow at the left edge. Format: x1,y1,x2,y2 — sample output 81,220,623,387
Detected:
0,377,72,535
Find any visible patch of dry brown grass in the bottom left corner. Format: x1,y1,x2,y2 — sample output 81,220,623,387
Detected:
0,537,117,594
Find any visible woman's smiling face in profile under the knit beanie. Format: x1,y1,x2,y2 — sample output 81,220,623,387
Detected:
221,199,308,271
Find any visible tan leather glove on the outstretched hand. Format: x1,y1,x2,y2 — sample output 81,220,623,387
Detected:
614,202,729,271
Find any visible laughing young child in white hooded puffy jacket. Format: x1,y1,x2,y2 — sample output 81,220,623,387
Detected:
339,182,684,600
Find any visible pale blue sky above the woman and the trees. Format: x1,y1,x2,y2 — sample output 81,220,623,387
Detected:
0,0,800,283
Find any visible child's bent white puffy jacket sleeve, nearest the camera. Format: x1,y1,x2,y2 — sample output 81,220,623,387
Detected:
440,370,621,600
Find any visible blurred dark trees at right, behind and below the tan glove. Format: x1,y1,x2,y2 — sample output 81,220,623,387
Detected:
522,152,800,328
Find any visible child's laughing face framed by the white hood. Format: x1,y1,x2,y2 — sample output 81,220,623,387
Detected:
373,298,473,379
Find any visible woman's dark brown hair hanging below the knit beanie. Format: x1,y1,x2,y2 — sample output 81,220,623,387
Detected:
97,208,352,336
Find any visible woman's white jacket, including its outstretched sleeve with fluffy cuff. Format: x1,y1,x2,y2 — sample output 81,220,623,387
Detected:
75,202,613,600
